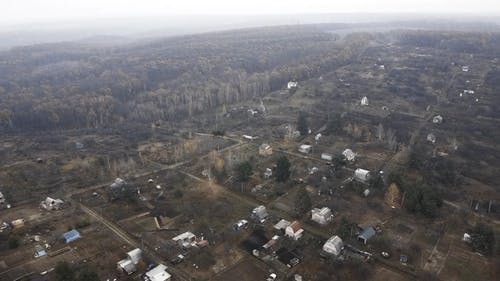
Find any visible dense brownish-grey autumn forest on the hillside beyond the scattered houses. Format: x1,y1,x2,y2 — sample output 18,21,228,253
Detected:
0,25,500,131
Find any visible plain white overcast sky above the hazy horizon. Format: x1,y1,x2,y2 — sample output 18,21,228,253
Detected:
0,0,500,24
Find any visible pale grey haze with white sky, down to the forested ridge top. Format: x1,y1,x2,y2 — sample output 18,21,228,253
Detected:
0,0,500,49
